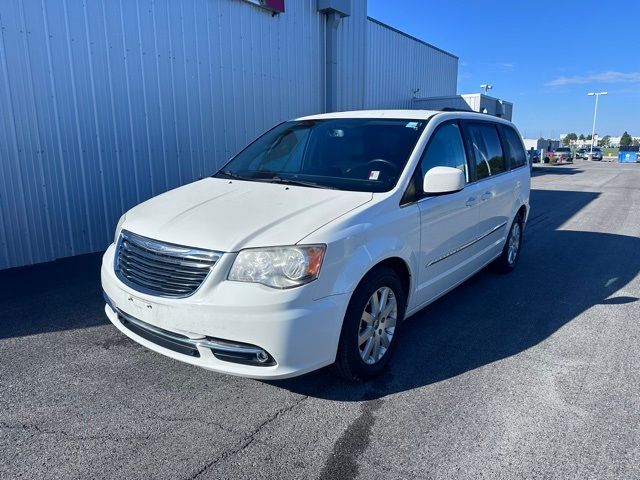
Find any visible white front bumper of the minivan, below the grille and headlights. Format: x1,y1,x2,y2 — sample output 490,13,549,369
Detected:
101,245,349,379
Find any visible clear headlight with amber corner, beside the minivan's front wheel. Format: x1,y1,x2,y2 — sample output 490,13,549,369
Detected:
228,245,327,288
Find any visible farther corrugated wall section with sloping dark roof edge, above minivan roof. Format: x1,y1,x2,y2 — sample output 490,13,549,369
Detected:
364,18,458,108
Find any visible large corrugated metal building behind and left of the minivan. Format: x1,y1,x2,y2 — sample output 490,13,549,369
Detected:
0,0,458,269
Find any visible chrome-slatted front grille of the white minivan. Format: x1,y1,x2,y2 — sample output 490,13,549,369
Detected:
114,230,222,297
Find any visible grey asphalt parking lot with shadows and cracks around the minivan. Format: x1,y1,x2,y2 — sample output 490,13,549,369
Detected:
0,161,640,479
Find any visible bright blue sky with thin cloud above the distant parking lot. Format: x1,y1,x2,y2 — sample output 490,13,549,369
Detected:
368,0,640,137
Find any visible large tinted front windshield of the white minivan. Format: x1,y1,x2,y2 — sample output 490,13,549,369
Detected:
215,118,427,192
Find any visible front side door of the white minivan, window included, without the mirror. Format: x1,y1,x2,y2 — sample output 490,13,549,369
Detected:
417,121,481,305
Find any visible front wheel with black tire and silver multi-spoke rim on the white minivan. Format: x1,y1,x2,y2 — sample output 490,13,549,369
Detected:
333,267,407,382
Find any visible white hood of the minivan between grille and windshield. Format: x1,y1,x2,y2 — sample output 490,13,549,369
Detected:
123,178,373,252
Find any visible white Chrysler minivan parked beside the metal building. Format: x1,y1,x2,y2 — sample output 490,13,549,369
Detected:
101,110,530,380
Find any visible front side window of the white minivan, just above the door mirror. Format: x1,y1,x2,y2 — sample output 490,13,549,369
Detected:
419,123,468,186
